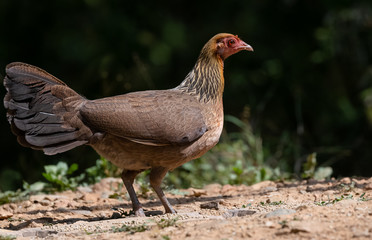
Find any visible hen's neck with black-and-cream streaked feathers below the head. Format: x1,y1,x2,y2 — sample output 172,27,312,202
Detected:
176,51,224,102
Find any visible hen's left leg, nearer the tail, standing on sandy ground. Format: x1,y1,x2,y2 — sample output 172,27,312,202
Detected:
121,170,145,217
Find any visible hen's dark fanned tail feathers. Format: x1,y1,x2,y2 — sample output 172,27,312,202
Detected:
4,63,92,155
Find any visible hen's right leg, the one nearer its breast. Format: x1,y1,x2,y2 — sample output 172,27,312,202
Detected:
150,167,176,213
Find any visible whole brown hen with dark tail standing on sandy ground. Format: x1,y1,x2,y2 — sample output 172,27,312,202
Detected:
4,33,253,217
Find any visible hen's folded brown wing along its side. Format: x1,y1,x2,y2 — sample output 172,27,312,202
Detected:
80,90,208,146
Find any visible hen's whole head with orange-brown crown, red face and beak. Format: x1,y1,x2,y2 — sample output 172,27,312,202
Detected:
203,33,253,60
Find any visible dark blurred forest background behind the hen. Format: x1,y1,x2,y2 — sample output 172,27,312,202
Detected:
0,0,372,190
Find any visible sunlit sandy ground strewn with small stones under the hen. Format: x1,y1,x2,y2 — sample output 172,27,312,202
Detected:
0,178,372,240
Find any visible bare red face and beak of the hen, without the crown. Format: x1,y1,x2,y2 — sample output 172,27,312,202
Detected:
217,36,253,60
